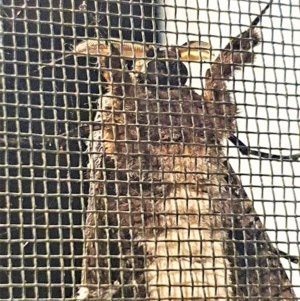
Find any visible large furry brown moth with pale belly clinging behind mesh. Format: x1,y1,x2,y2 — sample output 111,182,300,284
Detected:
75,1,296,301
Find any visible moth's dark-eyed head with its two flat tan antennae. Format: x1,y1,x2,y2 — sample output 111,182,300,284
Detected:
75,39,211,88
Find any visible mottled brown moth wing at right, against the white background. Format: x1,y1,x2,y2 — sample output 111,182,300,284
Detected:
223,163,297,301
